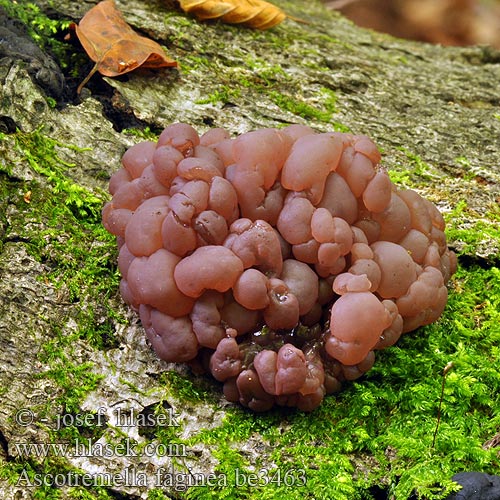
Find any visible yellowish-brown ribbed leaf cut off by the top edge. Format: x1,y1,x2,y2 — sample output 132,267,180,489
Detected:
180,0,289,30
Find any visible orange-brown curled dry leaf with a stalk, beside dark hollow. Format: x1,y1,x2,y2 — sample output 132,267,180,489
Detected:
71,0,177,92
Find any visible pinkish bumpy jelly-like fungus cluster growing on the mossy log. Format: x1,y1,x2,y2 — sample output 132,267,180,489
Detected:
103,123,456,411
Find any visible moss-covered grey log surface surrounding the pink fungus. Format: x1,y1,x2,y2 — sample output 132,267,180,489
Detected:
0,0,500,500
